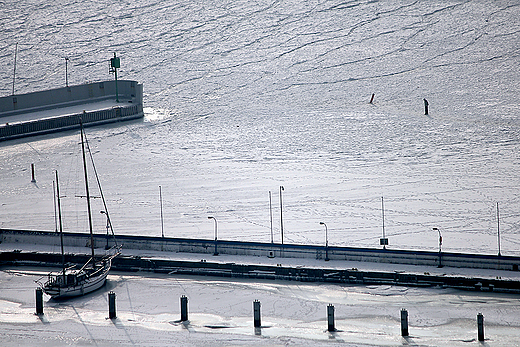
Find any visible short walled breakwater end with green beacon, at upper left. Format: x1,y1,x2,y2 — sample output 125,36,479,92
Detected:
0,80,144,141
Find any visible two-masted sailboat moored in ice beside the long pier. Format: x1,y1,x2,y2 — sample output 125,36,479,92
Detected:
40,122,121,298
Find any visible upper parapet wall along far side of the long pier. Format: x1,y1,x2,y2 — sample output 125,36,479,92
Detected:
0,229,520,271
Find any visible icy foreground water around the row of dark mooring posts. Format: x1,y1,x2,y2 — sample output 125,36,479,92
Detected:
0,268,520,346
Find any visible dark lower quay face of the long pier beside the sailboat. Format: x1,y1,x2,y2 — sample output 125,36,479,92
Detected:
0,251,520,294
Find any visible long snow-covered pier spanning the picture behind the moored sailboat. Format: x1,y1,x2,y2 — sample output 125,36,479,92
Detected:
0,229,520,293
